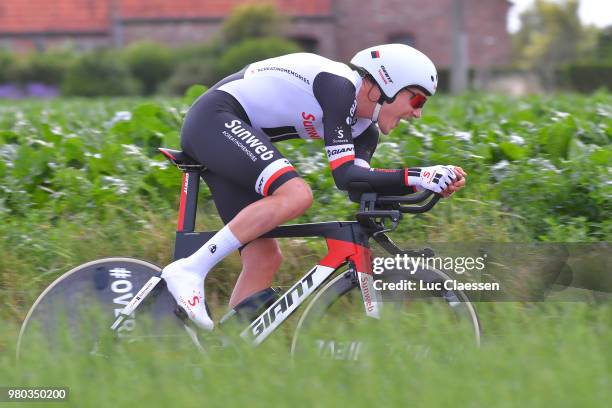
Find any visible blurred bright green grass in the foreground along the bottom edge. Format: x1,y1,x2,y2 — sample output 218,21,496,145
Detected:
0,302,612,407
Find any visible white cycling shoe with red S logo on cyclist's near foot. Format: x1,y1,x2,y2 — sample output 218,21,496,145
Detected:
161,259,215,331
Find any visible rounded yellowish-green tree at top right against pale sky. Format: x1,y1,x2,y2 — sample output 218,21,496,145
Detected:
513,0,587,88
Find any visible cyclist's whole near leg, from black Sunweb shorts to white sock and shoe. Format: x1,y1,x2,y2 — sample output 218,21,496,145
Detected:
162,91,312,329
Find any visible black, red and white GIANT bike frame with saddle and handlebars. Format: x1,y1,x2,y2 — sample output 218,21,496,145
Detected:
111,148,439,344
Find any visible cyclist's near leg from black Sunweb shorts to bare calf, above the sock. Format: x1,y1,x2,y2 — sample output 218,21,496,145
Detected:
181,91,312,244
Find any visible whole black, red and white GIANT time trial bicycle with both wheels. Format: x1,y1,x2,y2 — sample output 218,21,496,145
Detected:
17,148,481,360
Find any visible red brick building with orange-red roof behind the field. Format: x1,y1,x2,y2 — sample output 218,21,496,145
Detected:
0,0,511,67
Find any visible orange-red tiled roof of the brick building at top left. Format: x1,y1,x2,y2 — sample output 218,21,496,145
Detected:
0,0,331,33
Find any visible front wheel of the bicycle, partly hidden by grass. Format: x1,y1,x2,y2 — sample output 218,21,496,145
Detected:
292,269,481,360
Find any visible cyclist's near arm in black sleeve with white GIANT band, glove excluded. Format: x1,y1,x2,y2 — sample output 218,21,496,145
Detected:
313,72,414,194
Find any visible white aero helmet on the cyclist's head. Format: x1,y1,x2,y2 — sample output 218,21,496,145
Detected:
351,44,438,105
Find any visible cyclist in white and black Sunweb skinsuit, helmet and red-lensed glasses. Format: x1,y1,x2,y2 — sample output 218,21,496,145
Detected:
162,44,466,330
